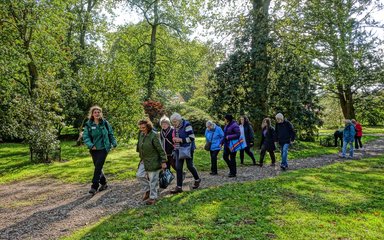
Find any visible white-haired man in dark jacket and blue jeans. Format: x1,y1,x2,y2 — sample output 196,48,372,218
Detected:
275,113,295,171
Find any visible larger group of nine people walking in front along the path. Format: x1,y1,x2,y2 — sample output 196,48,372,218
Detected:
83,106,295,205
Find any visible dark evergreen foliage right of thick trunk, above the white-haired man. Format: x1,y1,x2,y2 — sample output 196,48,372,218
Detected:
268,47,322,141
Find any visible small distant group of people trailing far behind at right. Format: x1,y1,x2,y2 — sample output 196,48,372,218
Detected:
333,119,364,158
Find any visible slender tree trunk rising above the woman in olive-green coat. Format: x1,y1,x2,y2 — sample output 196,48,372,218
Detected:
145,1,159,100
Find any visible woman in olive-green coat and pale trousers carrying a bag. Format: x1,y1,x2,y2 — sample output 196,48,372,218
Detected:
136,119,167,205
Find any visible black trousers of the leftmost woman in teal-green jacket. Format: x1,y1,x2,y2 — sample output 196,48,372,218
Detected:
90,149,108,190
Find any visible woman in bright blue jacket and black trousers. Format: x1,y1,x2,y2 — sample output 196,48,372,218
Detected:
205,121,224,175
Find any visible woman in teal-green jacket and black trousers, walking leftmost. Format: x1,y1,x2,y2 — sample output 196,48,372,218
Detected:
83,106,117,194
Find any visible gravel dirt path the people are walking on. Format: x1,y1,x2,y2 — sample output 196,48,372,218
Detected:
0,138,384,239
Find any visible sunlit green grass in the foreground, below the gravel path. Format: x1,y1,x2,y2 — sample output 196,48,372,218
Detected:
67,156,384,239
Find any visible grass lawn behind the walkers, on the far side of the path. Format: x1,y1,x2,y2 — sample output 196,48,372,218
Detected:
0,136,377,184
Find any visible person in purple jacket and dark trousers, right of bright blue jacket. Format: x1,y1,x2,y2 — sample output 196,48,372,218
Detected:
221,114,241,177
